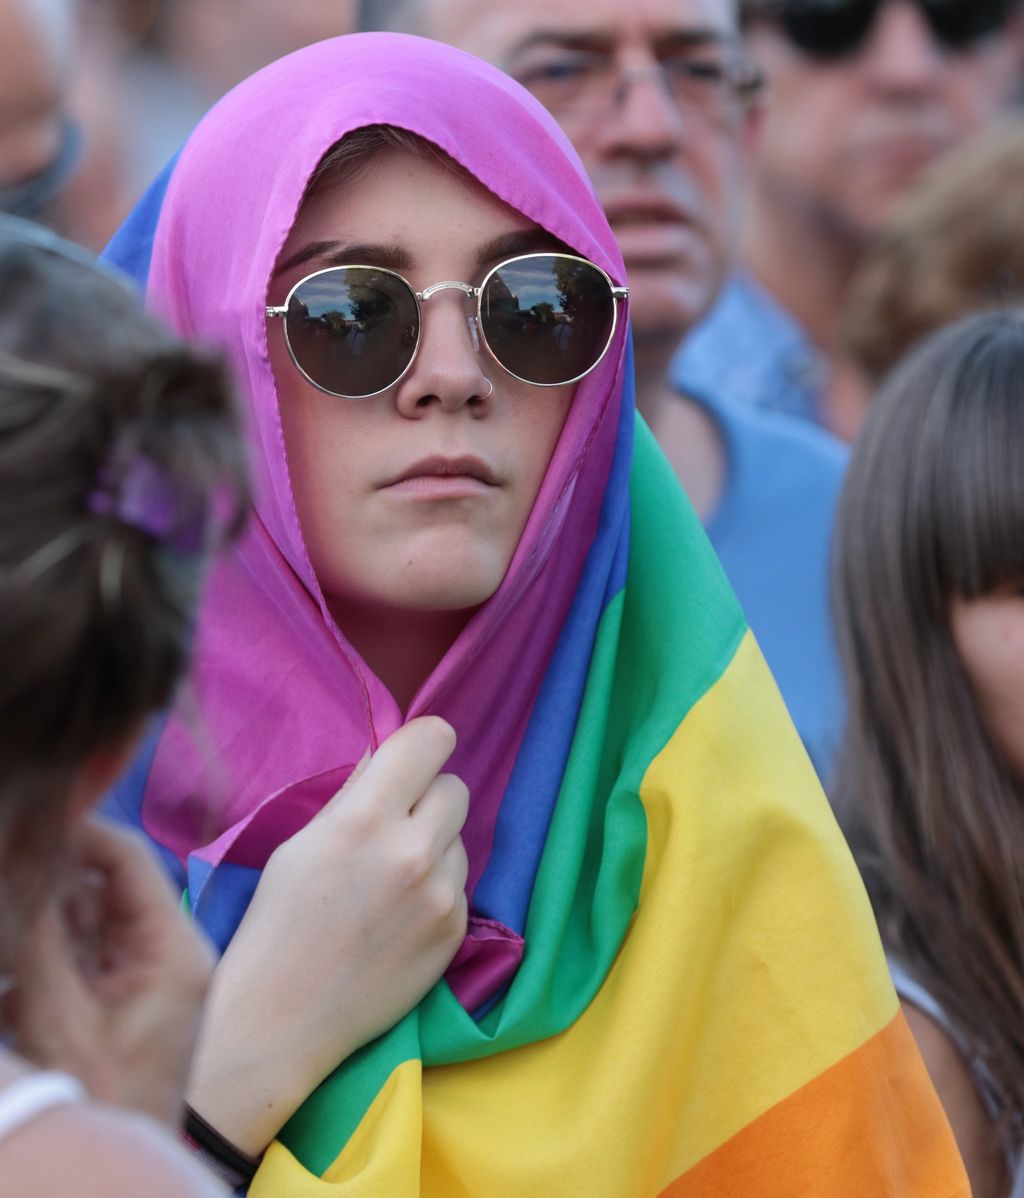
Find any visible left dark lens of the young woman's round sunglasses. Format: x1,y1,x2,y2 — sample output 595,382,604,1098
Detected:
285,266,419,397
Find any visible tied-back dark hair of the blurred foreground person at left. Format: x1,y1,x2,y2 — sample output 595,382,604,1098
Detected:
0,225,246,951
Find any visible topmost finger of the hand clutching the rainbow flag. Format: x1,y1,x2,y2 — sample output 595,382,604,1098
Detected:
325,715,455,813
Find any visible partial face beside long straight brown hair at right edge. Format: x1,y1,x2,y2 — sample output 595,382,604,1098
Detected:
951,591,1024,780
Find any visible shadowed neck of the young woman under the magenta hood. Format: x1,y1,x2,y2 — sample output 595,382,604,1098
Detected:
331,601,473,713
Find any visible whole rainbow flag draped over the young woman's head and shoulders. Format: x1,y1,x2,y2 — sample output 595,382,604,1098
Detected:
105,35,968,1198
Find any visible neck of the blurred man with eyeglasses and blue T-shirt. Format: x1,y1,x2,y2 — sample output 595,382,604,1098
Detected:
634,331,727,521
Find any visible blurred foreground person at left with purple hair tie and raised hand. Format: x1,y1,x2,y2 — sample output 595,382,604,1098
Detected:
0,217,244,1198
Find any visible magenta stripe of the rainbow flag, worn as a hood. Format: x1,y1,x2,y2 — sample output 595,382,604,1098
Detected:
143,34,625,1009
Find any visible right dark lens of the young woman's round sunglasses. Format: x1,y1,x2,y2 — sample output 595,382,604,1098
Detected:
480,254,616,383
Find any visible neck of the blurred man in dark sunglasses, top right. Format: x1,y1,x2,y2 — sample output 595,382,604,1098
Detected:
744,187,864,361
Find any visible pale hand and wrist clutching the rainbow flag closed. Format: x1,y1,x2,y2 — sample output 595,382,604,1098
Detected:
188,716,468,1156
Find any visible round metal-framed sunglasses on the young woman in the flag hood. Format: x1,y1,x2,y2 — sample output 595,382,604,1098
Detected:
266,254,629,399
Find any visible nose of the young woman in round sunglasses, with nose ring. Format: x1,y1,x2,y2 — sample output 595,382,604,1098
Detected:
395,290,493,419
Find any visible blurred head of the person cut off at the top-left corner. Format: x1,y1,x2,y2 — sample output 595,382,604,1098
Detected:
0,0,80,219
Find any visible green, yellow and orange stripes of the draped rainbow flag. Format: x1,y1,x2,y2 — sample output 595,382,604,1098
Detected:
229,416,969,1198
